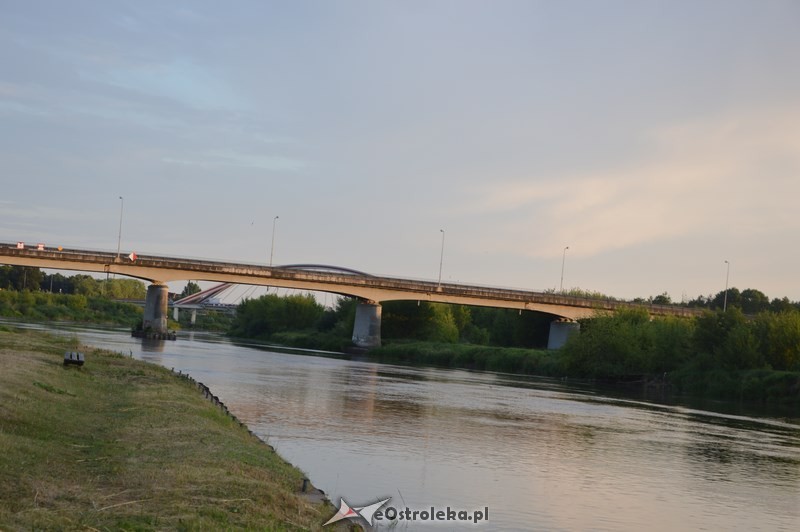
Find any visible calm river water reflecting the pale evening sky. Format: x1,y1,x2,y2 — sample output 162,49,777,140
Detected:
14,322,800,531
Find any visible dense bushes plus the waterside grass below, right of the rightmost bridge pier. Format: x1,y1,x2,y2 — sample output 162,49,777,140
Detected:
562,308,800,402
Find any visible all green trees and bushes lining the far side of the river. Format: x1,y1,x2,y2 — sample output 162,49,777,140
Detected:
0,267,800,400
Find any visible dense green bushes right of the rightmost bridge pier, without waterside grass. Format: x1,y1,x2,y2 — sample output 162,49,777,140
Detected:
563,308,800,378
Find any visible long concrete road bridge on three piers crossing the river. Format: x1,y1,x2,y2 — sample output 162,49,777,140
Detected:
0,243,698,348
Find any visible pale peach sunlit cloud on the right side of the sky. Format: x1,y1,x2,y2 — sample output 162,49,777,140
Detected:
460,108,800,257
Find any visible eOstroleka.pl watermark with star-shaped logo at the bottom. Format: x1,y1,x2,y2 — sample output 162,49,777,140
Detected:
323,497,489,526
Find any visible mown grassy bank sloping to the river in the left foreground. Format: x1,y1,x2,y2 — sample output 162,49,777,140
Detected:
0,326,346,530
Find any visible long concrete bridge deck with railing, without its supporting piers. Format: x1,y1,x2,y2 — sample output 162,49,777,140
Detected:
0,243,701,319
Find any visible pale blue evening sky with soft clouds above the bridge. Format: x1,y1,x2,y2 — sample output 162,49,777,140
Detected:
0,0,800,301
